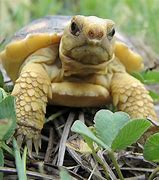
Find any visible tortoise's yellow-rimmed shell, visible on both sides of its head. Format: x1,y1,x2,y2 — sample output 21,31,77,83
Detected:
0,16,143,81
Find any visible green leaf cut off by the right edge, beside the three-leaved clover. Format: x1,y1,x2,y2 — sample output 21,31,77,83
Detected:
143,133,159,162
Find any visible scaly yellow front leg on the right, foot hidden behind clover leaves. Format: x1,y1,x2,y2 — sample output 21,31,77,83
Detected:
111,73,157,120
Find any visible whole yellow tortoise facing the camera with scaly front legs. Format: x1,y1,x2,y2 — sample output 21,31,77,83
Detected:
0,15,157,155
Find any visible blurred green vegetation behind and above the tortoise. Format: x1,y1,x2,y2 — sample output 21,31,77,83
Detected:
0,0,159,53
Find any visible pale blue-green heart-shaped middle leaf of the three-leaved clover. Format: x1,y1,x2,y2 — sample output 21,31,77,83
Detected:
94,110,129,147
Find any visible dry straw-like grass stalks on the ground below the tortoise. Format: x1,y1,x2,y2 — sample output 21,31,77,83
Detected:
3,106,157,180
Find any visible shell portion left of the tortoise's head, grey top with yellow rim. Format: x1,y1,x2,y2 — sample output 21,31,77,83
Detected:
1,16,71,81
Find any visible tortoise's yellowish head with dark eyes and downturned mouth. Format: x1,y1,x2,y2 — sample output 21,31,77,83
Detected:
60,16,115,65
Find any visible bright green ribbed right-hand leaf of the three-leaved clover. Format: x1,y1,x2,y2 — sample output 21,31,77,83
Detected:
112,119,151,151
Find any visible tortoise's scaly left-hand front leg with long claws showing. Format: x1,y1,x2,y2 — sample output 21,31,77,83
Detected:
12,63,52,156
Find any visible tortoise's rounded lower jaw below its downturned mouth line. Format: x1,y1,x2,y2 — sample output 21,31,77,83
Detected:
68,45,111,65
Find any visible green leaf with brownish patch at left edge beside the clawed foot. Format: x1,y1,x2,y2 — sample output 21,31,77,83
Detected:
0,96,16,141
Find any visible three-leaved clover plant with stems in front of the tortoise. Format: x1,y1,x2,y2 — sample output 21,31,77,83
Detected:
71,110,151,180
